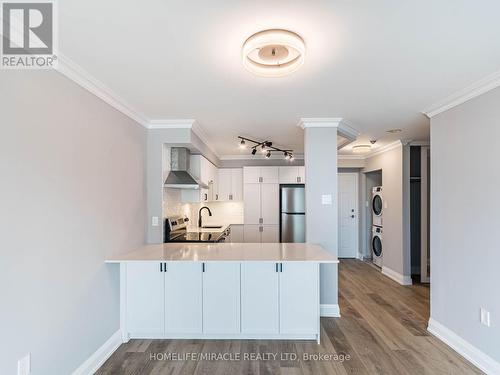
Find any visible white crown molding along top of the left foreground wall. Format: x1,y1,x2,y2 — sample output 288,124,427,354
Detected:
55,53,149,128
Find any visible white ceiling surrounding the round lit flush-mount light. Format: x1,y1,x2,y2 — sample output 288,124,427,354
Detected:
58,0,500,155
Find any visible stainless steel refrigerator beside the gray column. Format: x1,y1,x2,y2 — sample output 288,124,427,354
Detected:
280,185,306,242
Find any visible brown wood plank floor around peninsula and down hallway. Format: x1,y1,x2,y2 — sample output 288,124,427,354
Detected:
97,260,481,375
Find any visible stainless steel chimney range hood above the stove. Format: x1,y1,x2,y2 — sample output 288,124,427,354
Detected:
164,147,208,189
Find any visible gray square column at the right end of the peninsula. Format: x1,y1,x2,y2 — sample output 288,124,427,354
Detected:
304,128,338,304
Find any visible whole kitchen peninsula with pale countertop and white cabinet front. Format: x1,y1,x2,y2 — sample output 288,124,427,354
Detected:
106,243,338,342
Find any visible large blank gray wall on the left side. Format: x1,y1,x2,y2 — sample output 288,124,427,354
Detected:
0,70,146,375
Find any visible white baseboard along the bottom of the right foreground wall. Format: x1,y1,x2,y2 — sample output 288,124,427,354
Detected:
427,318,500,374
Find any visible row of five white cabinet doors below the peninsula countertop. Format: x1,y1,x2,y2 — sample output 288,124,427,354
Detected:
125,261,319,339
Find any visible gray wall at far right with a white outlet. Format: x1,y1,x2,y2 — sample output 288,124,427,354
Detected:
430,88,500,362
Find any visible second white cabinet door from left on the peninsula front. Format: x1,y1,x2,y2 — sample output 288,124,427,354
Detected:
164,262,202,334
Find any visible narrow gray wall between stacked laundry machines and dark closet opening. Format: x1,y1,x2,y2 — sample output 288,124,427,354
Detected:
363,144,411,276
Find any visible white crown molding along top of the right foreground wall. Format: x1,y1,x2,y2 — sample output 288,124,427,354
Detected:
422,71,500,118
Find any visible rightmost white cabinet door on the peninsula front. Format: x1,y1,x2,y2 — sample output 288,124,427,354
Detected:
279,262,319,335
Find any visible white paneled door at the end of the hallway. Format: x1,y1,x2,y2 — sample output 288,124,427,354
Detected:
338,173,358,258
